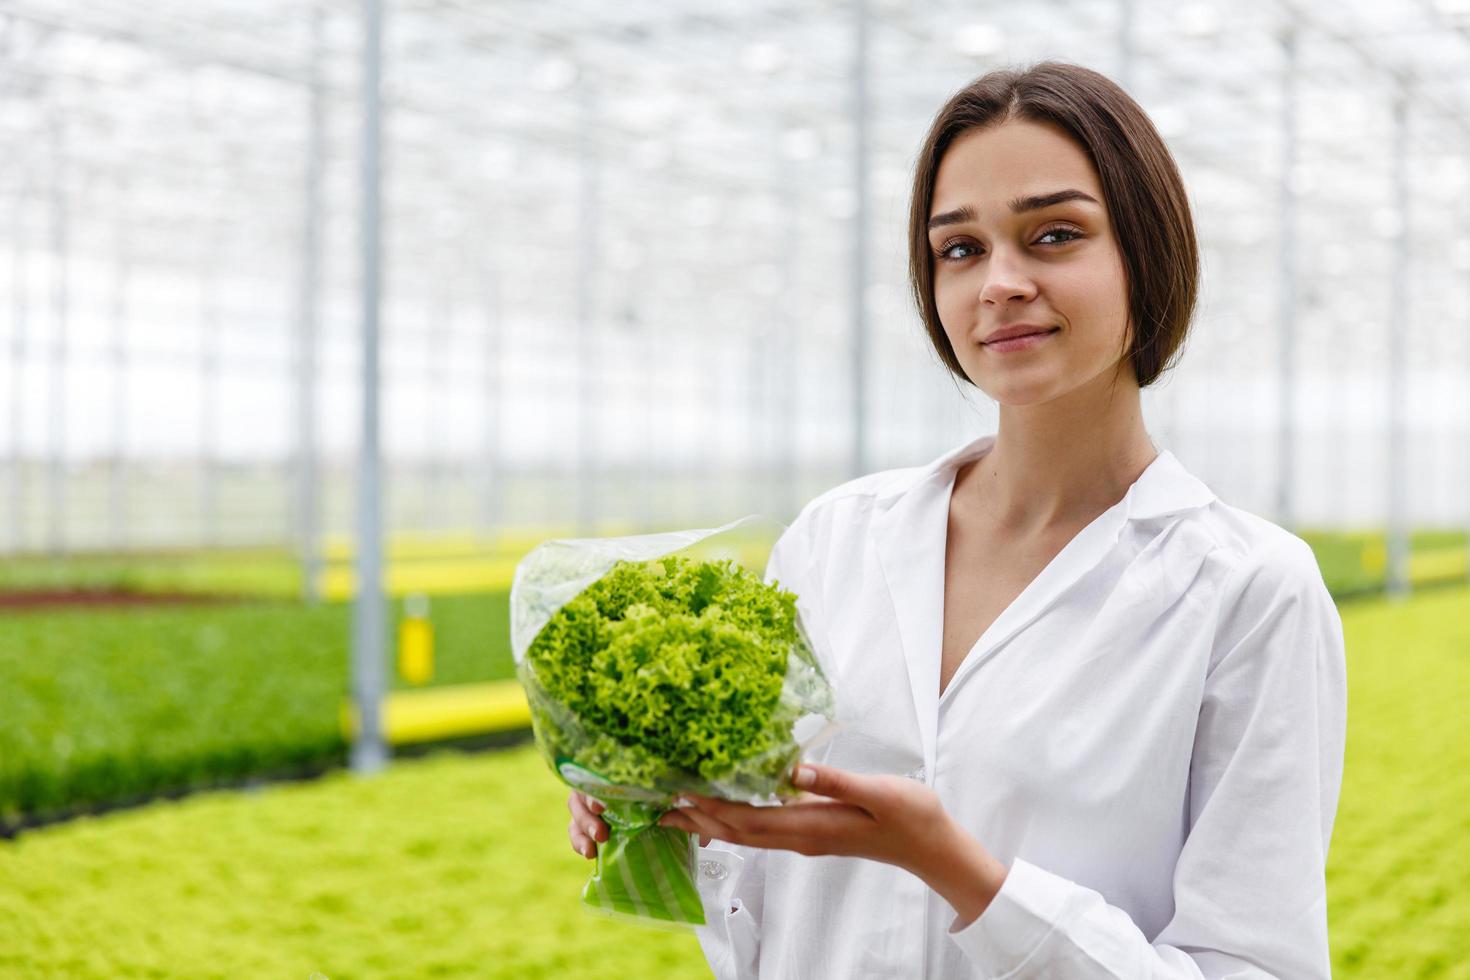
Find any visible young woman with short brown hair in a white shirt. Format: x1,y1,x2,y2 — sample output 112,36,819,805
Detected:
569,62,1347,980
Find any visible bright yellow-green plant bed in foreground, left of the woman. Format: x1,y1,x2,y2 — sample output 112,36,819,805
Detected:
0,746,709,980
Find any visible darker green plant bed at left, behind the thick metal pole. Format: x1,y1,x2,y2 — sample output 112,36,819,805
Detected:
0,594,515,824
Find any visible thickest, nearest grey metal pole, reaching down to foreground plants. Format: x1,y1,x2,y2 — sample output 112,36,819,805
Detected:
351,0,388,774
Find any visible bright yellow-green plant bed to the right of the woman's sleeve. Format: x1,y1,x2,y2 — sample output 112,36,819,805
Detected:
1327,588,1470,980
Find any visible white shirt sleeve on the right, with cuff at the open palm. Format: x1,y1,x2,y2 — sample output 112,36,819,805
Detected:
950,536,1347,980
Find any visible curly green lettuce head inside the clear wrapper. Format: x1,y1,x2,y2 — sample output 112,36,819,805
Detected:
522,555,831,793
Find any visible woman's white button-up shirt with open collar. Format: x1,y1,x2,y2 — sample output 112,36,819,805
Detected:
695,436,1347,980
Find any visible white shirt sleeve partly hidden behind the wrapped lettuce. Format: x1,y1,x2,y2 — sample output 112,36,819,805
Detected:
694,514,814,980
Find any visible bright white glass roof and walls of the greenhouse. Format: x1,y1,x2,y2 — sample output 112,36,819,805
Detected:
0,0,1470,547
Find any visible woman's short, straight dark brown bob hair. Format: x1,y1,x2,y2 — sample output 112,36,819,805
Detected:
908,60,1200,388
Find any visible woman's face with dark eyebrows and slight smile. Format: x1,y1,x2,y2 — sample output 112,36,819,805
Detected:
929,120,1138,406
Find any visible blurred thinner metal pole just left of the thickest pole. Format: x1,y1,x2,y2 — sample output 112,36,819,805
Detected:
294,4,326,605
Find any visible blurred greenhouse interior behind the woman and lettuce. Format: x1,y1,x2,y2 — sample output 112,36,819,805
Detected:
0,0,1470,977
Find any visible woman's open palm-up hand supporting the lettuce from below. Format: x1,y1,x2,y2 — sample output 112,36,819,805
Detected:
659,763,998,884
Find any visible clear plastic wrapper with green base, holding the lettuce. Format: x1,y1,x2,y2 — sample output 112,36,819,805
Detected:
510,516,836,929
